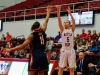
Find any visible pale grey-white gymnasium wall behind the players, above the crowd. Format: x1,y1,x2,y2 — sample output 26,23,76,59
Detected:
0,14,100,38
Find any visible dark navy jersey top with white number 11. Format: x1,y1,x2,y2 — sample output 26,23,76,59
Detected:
31,30,46,54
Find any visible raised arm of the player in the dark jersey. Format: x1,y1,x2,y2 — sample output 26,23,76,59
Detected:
41,6,52,31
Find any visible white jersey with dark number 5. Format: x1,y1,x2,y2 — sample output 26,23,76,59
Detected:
61,29,74,49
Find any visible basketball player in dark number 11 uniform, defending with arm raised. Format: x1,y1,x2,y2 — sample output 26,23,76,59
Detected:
7,6,52,75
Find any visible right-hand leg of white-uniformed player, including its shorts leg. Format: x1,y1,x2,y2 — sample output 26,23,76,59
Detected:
68,50,76,75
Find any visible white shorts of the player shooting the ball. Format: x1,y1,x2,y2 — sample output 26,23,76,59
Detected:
59,49,76,68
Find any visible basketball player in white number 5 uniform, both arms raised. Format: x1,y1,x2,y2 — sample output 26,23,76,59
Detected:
56,6,76,75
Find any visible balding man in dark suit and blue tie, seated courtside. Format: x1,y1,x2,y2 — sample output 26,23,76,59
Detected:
76,52,91,75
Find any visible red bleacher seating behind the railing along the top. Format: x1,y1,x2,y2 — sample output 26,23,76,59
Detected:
0,0,100,19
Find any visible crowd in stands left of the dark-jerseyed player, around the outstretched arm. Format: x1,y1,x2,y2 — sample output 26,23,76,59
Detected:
0,32,30,59
